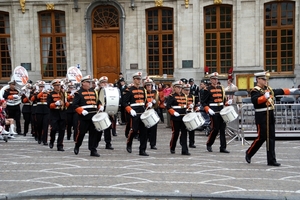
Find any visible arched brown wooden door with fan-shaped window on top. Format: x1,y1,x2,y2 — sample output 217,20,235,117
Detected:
92,6,120,83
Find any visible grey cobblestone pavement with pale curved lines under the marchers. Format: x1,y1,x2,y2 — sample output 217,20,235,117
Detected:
0,123,300,199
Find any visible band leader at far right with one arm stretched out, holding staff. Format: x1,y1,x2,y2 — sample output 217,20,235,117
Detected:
245,72,298,166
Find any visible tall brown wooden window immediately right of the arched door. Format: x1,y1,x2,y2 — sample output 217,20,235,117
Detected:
146,7,174,76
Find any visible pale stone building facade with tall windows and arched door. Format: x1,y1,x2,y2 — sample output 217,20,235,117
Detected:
0,0,300,89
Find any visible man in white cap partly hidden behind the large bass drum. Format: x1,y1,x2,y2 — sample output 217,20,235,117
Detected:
98,76,116,150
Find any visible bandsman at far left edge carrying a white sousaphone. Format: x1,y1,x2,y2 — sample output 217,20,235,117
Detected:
3,80,22,135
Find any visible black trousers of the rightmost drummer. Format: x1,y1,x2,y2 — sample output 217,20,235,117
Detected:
206,113,227,149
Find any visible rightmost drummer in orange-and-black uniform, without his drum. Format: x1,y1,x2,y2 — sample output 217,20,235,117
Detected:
201,72,232,153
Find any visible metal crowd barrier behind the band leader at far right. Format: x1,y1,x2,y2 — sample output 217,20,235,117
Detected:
226,97,300,145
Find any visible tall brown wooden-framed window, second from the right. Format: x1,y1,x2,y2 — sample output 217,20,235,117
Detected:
204,4,233,73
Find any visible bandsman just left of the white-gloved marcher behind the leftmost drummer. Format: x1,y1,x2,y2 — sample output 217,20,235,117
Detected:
32,81,49,145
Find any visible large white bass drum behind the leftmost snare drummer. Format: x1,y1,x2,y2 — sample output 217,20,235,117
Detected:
99,87,120,115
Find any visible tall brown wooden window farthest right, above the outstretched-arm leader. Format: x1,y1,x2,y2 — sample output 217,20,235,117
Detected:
264,1,295,73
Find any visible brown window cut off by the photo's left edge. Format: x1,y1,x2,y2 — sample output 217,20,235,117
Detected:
0,11,12,80
